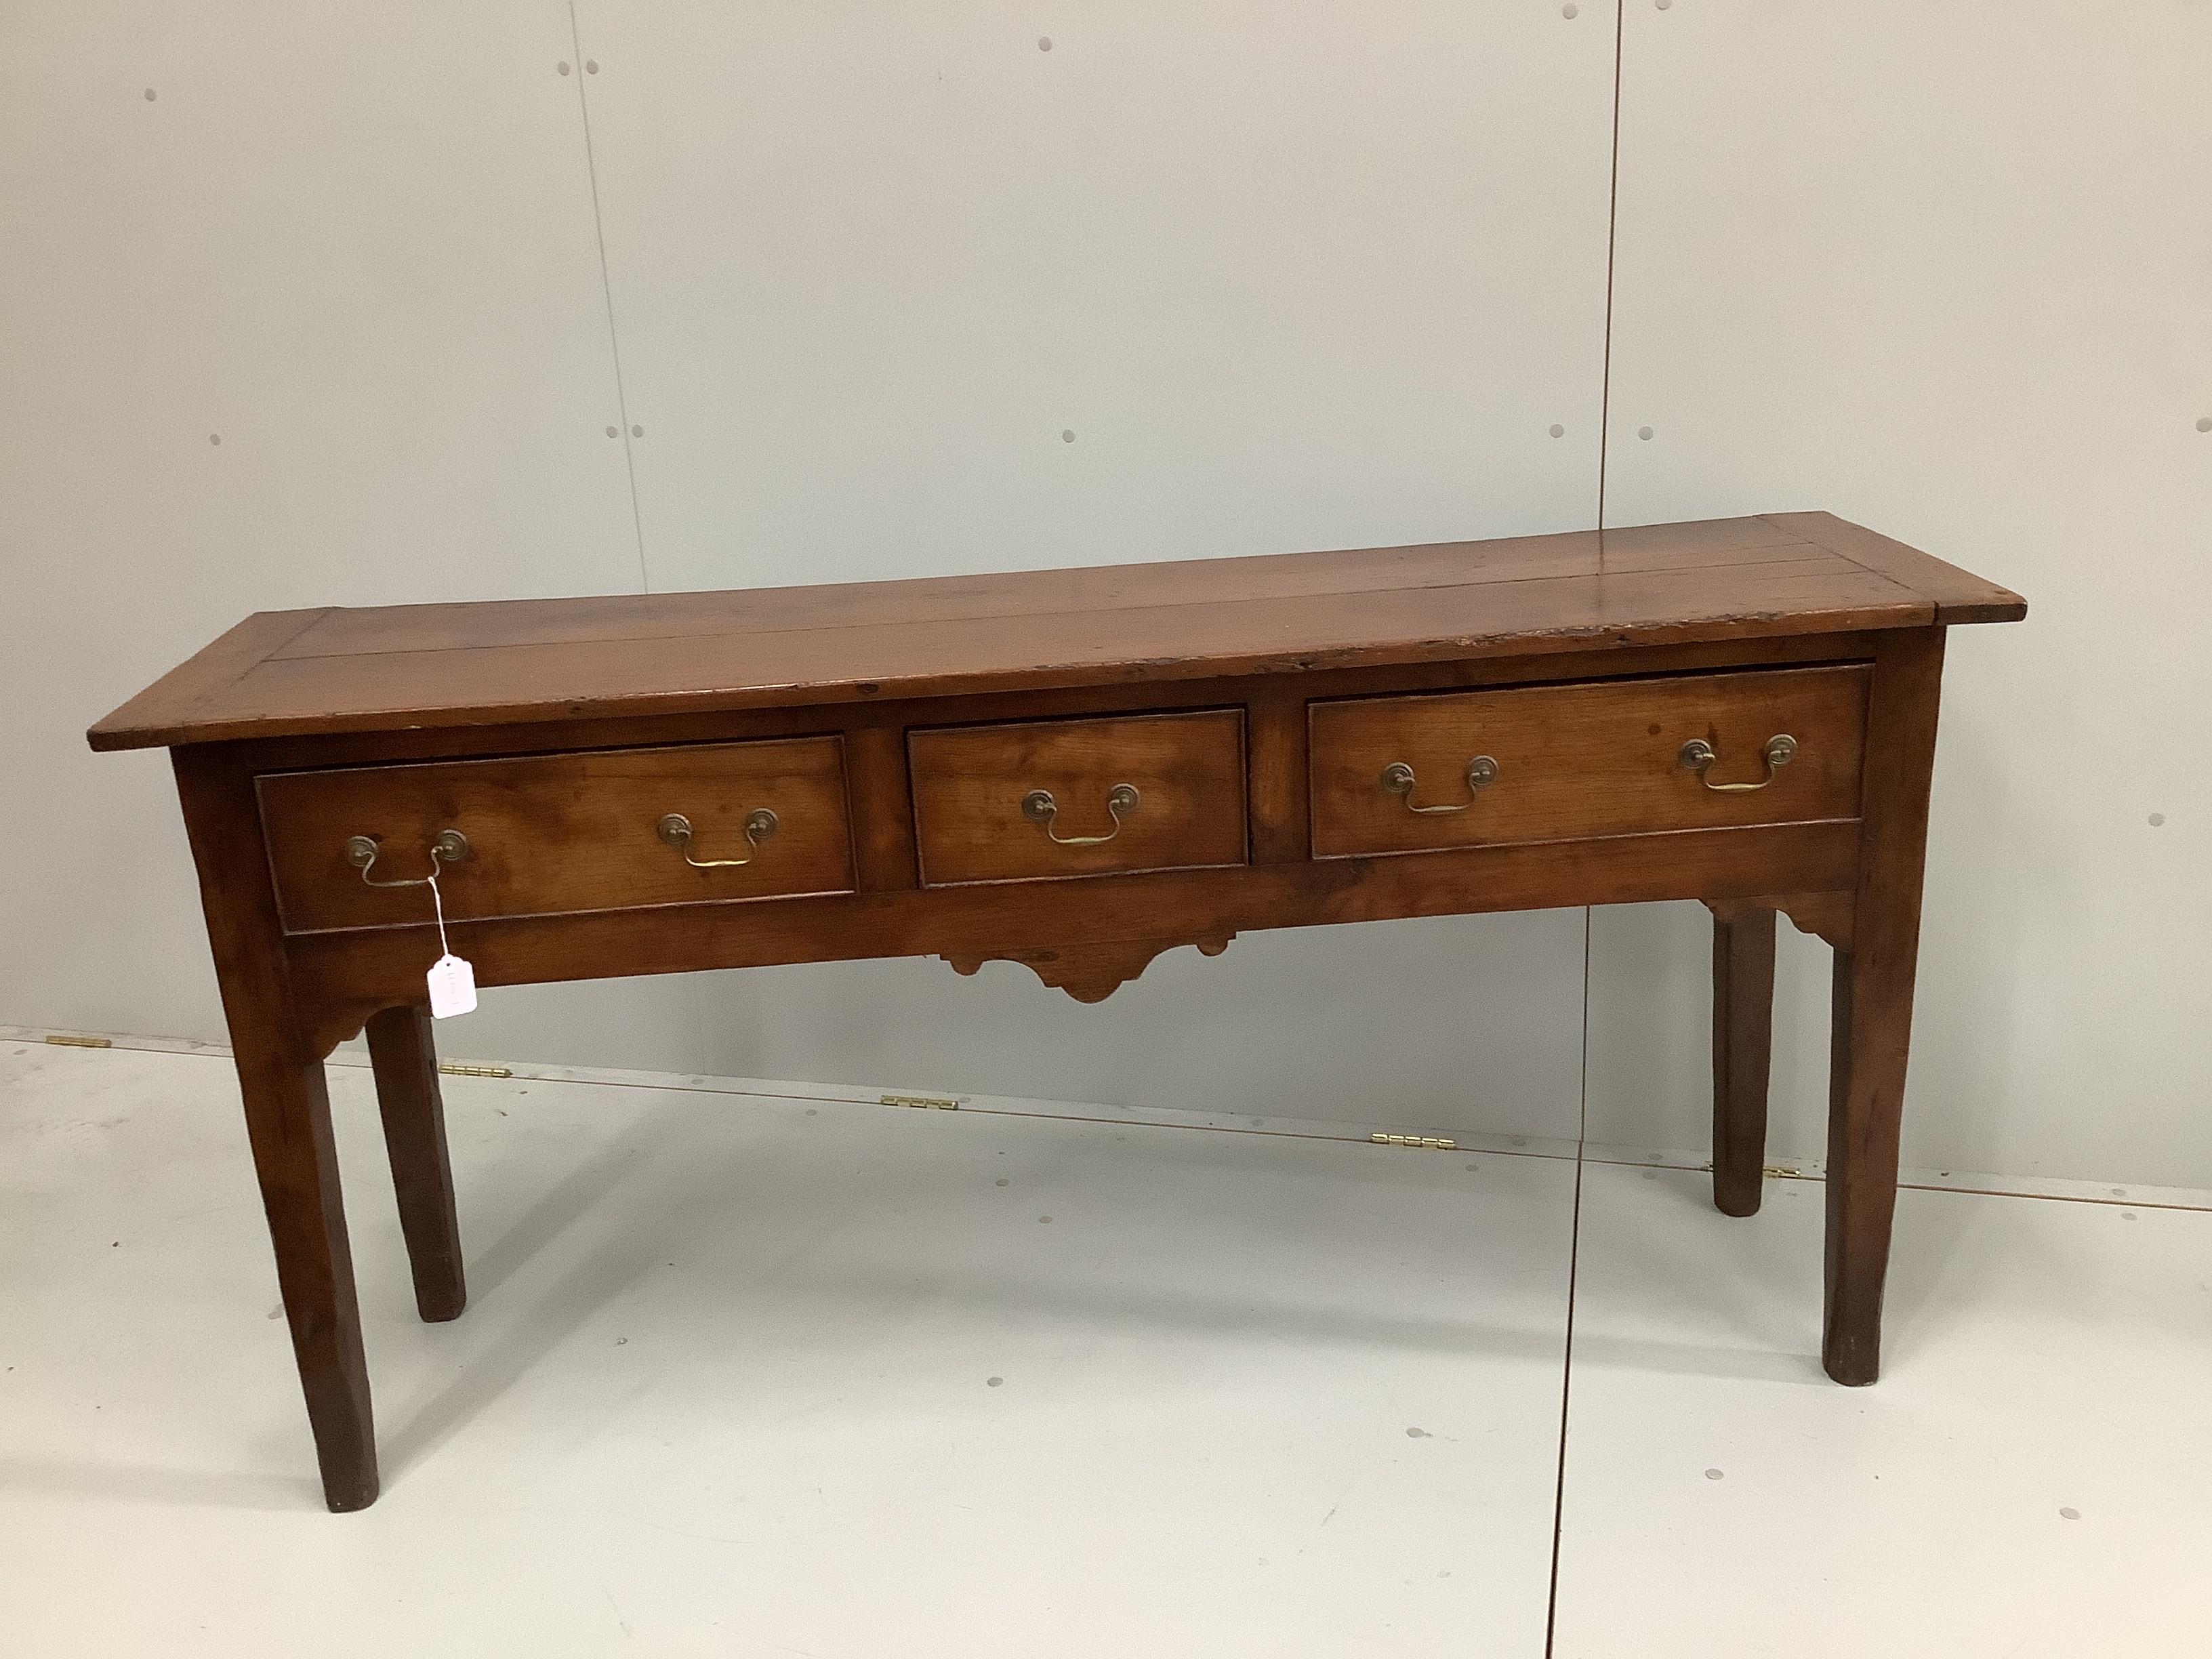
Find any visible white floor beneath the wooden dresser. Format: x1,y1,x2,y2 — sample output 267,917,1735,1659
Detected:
0,1042,2212,1659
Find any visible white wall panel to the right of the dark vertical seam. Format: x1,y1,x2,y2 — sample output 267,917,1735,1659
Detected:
1591,0,2212,1186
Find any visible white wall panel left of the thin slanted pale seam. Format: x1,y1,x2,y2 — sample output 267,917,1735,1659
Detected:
0,0,690,1079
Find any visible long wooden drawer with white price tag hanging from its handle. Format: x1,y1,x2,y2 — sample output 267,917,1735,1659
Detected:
259,737,852,933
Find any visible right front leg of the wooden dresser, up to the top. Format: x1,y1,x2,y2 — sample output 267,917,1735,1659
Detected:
1820,628,1942,1385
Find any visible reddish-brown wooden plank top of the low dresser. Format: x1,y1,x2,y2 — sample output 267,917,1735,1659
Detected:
86,513,2026,750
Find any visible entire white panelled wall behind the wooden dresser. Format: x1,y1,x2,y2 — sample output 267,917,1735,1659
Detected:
13,0,2212,1186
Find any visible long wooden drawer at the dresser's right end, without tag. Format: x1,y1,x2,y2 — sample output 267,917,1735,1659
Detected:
1307,665,1871,858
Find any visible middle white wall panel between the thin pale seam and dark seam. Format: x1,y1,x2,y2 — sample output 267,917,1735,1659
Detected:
579,0,1612,1134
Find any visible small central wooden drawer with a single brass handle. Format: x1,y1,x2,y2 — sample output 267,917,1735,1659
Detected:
907,708,1246,887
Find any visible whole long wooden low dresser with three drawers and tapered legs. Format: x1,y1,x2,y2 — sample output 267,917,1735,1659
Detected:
91,513,2026,1509
